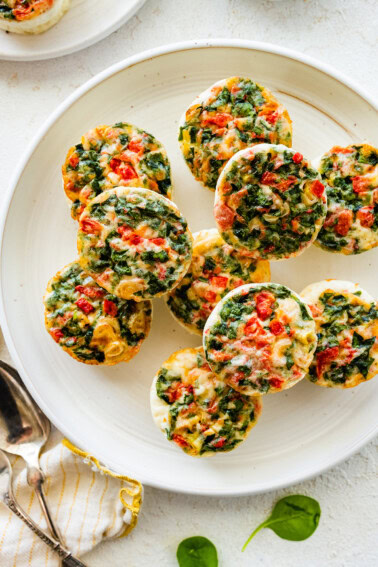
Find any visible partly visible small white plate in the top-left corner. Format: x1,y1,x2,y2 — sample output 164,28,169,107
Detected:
0,0,145,61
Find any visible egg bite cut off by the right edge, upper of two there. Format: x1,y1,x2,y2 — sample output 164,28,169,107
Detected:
315,144,378,254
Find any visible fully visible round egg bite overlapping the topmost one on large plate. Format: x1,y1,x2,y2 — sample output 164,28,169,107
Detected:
214,144,327,260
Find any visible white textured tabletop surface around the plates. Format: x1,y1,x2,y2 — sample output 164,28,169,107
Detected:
0,0,378,567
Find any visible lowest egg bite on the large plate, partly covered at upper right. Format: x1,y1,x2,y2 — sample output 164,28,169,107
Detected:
150,347,262,457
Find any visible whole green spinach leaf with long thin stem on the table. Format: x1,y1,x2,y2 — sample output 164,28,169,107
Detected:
242,494,321,551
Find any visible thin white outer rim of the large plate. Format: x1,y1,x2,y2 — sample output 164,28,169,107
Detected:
0,38,378,496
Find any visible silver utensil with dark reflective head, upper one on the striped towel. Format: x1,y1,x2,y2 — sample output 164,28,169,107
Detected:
0,361,62,542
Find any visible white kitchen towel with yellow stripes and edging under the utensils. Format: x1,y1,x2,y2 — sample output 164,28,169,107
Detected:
0,431,142,567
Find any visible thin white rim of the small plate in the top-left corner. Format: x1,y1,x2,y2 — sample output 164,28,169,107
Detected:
0,0,146,61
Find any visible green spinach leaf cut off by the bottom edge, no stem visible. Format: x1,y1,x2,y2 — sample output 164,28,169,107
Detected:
177,536,218,567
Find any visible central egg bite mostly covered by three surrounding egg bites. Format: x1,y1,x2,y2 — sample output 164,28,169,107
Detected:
167,228,270,336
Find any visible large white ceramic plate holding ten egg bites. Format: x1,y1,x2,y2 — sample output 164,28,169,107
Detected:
1,41,378,495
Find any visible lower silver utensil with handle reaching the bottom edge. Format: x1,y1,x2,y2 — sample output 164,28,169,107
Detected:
0,450,85,567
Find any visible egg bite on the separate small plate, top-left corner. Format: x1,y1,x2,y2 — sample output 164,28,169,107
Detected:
0,0,71,34
